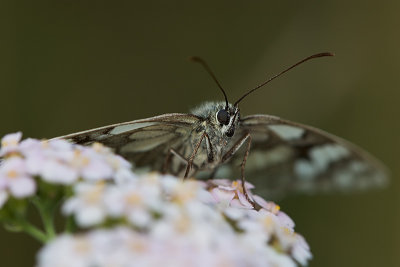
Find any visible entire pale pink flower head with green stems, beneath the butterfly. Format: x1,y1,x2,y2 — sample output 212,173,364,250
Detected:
0,133,312,267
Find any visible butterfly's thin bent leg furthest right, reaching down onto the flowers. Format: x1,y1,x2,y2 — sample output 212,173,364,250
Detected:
221,133,259,209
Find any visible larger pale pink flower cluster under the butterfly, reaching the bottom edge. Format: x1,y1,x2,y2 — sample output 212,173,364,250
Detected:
42,173,311,267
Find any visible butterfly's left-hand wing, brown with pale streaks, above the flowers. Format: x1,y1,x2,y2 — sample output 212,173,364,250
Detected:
58,113,200,170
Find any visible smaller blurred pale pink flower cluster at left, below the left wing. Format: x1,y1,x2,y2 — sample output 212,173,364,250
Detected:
0,132,131,207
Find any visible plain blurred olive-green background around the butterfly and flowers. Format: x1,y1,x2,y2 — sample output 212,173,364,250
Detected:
0,0,400,267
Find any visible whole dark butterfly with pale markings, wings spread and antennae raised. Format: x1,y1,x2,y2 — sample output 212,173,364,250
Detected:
56,53,387,200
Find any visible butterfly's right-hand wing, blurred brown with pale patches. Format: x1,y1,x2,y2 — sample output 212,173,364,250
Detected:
219,115,387,197
